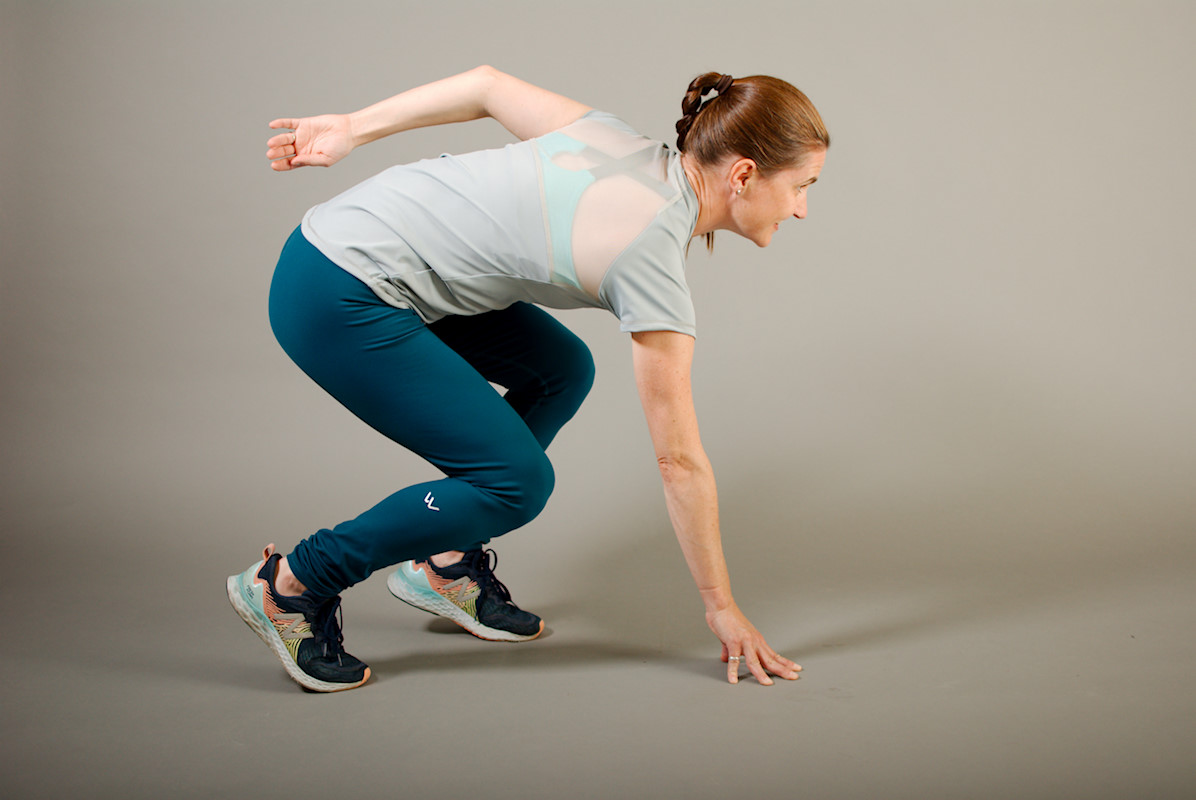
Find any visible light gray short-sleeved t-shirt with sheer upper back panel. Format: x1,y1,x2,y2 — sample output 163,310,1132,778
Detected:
303,111,697,336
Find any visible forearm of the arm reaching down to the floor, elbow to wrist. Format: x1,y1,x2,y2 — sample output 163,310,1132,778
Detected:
660,456,734,613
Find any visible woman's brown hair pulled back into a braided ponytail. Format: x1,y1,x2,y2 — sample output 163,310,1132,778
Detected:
677,72,830,249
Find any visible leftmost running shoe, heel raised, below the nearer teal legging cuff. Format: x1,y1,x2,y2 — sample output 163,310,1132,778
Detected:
228,544,370,691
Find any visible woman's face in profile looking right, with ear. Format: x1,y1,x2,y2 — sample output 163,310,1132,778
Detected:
731,149,826,248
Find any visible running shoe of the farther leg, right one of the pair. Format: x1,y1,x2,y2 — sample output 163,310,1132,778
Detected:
386,549,544,642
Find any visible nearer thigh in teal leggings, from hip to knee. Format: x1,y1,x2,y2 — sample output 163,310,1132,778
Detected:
270,234,542,484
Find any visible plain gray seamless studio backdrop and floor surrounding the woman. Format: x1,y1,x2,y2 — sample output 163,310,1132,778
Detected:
0,0,1196,798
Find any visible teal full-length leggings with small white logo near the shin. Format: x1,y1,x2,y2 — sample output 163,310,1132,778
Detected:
270,230,594,597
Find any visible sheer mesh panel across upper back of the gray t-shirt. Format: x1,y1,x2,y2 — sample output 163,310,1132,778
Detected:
537,118,677,298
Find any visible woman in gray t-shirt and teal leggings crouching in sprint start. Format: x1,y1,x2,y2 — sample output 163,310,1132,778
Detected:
227,67,830,691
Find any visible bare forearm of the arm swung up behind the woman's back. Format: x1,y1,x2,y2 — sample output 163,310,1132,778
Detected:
349,67,499,146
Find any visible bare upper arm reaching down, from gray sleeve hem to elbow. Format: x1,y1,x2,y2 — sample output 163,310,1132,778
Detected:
631,330,706,468
